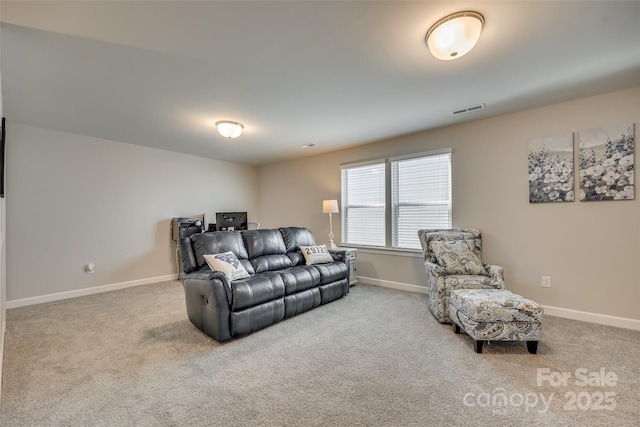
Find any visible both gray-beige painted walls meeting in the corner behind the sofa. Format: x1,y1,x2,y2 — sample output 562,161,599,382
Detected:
6,88,640,319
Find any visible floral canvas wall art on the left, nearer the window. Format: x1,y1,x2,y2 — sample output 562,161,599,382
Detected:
529,133,575,203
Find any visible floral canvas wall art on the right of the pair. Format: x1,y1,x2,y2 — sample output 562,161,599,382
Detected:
579,123,635,201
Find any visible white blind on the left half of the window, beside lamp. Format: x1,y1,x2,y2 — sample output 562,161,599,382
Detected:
340,160,386,247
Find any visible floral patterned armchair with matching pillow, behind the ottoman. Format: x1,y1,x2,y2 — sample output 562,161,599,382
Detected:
418,229,505,323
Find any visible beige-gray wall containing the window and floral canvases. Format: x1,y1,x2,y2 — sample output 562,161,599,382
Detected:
260,88,640,320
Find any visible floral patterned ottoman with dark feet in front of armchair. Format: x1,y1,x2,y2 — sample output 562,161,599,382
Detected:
449,289,542,354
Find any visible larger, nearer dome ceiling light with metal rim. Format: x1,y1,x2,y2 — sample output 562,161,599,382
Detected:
425,11,484,61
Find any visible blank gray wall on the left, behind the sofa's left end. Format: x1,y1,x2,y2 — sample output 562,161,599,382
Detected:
7,123,259,302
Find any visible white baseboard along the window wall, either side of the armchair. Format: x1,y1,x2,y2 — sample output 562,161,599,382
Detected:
358,276,640,331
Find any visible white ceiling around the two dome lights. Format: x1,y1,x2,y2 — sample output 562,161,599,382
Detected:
0,0,640,165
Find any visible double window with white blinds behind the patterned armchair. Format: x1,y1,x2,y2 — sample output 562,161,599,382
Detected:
341,149,451,249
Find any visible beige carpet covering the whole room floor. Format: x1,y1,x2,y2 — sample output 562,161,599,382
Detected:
0,281,640,426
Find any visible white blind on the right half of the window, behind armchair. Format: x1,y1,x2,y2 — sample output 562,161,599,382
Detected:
390,152,451,249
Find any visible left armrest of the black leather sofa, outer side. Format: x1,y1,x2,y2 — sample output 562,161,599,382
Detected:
184,270,231,342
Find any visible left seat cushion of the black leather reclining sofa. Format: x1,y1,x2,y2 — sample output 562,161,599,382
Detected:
231,272,284,311
